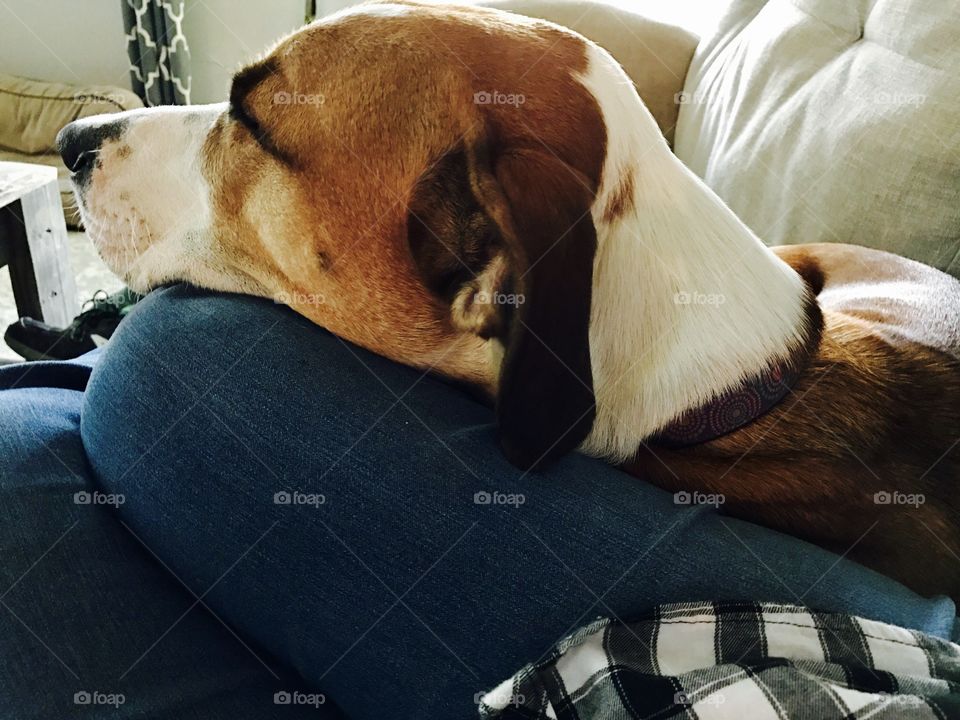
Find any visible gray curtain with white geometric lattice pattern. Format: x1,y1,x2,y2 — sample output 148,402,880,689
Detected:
120,0,191,107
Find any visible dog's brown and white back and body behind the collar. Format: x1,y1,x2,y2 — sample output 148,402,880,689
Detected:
628,244,960,598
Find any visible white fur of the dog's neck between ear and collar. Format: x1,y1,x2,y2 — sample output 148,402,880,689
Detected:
583,49,819,460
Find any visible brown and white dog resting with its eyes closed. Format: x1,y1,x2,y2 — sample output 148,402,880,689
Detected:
59,2,960,598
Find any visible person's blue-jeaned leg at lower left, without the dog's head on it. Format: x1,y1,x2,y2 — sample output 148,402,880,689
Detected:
0,356,341,720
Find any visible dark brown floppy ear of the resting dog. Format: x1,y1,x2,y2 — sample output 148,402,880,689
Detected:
409,145,597,469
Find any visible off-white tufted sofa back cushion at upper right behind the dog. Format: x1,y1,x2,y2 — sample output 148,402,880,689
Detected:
675,0,960,275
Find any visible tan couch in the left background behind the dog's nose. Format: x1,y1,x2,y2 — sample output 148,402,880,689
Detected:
0,73,143,227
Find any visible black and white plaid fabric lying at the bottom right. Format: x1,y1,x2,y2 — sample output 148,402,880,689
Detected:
477,603,960,720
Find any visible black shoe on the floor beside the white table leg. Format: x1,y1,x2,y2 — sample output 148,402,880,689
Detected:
3,288,142,360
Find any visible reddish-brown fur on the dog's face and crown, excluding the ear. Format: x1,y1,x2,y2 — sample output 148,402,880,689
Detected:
205,3,606,388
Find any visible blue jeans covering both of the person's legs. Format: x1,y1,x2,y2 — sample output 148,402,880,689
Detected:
0,286,954,720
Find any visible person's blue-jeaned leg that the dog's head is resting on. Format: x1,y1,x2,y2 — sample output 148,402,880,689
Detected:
82,286,954,720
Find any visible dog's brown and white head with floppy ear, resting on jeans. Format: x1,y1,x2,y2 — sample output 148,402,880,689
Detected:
60,2,663,466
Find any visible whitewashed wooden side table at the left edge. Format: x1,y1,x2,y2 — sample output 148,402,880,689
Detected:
0,162,78,327
